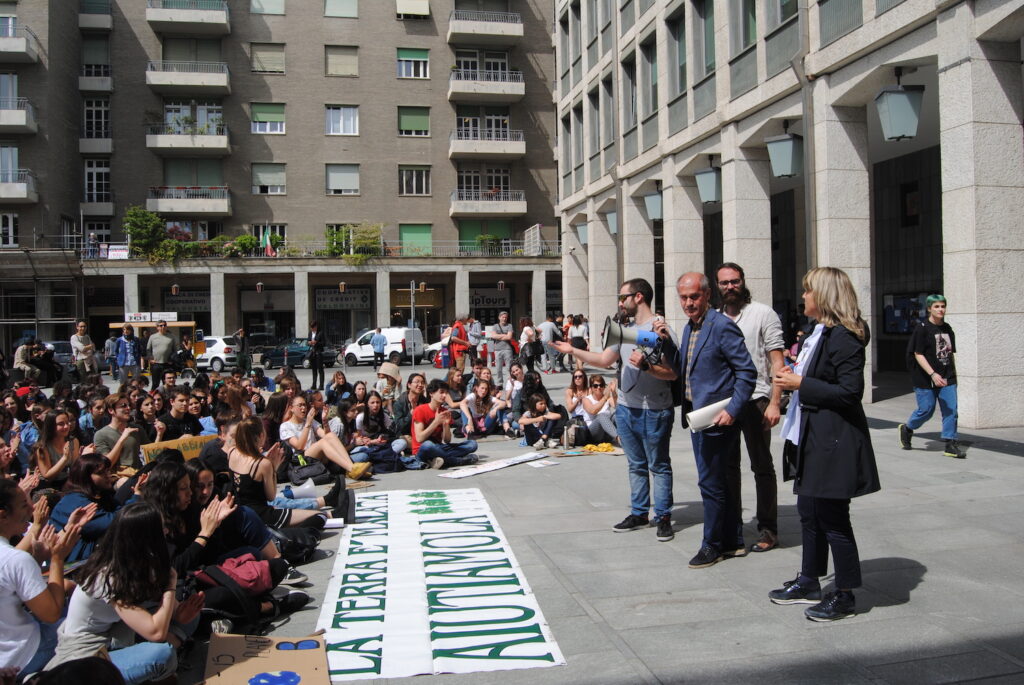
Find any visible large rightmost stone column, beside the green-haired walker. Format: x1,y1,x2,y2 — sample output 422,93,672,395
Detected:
938,4,1024,428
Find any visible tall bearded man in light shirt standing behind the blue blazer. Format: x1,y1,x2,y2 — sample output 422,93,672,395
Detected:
715,262,785,552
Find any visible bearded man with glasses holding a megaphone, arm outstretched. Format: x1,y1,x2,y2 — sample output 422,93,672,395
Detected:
552,279,678,542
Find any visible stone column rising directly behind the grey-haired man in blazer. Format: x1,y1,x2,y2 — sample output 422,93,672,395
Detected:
662,176,708,332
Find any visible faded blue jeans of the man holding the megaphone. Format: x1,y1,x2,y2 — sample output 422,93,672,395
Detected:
615,404,675,518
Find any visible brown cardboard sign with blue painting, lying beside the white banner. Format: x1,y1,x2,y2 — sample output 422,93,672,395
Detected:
205,633,331,685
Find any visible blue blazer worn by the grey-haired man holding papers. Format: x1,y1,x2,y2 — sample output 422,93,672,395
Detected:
676,309,758,426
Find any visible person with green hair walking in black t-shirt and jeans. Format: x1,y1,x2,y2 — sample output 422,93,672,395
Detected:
897,295,967,459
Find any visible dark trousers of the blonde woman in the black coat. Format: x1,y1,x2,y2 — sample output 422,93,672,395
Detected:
797,495,860,590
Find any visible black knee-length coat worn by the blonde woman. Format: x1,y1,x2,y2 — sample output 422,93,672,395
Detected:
782,326,881,500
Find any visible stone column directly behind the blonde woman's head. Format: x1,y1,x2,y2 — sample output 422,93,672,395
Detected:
813,77,874,402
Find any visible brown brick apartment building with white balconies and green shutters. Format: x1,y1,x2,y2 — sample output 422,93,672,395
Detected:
0,0,561,352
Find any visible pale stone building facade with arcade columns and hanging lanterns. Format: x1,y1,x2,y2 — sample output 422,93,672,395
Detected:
553,0,1024,427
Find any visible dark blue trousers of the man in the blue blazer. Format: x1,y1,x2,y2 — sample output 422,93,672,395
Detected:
692,424,744,552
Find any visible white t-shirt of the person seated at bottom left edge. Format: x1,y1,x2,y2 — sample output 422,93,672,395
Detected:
0,538,46,670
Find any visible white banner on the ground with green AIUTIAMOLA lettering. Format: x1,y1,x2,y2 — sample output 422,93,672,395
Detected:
317,488,565,683
